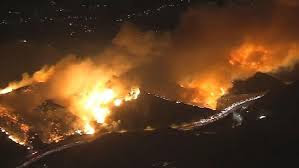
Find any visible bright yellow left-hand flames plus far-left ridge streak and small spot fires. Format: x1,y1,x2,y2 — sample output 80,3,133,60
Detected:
0,70,140,142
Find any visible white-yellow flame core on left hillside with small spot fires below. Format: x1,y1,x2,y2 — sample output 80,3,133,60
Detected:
2,85,140,142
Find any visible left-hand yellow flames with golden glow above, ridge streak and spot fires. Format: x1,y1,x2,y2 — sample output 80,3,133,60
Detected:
0,58,140,144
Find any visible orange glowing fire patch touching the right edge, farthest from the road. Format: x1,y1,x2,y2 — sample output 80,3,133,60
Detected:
229,41,299,73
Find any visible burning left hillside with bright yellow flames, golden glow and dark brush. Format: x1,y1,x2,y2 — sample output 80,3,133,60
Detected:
0,57,140,144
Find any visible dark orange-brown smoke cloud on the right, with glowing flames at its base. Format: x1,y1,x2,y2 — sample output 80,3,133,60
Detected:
121,1,299,108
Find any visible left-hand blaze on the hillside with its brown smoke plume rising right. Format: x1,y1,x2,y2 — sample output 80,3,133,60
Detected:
1,24,165,142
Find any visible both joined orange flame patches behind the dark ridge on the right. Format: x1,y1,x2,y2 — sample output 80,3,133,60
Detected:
179,40,299,109
